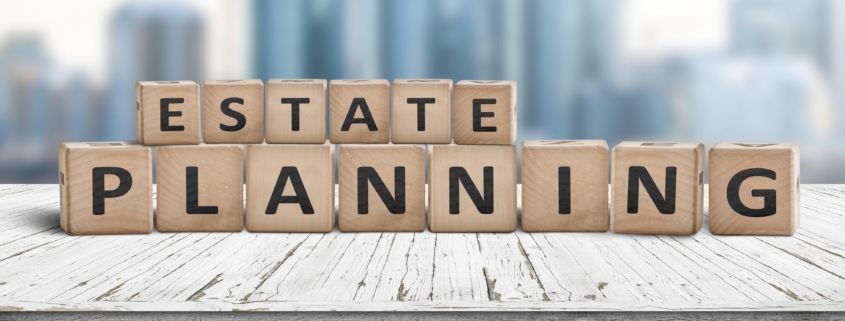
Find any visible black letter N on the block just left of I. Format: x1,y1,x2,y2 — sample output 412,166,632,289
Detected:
449,166,493,214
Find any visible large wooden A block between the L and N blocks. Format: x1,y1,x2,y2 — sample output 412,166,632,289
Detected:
246,142,334,232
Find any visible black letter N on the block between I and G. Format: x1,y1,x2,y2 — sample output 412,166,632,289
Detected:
628,166,678,214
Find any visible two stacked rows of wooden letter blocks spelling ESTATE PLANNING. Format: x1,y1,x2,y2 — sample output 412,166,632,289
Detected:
59,79,799,235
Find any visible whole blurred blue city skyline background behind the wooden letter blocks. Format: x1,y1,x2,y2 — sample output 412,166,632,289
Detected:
0,0,845,183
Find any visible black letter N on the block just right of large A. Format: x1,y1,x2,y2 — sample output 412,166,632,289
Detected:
358,166,405,214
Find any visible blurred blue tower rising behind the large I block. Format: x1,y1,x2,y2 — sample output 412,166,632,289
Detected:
525,0,621,141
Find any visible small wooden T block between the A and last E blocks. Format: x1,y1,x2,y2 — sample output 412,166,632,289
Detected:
390,79,452,144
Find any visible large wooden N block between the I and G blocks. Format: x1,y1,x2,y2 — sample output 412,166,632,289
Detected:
610,142,704,235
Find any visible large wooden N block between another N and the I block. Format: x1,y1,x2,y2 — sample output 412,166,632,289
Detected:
428,144,516,232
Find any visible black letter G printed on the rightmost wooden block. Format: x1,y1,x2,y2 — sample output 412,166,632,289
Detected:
728,168,777,217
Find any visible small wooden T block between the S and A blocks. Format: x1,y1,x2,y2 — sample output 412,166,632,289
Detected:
265,79,326,144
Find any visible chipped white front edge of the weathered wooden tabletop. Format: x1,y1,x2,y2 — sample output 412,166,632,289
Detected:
0,301,845,313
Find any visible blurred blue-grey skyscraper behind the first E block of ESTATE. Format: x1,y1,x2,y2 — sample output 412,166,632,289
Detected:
103,2,205,140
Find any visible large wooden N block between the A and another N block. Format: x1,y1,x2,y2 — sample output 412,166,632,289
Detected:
337,144,425,232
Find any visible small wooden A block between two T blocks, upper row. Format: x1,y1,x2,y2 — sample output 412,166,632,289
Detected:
329,79,390,144
